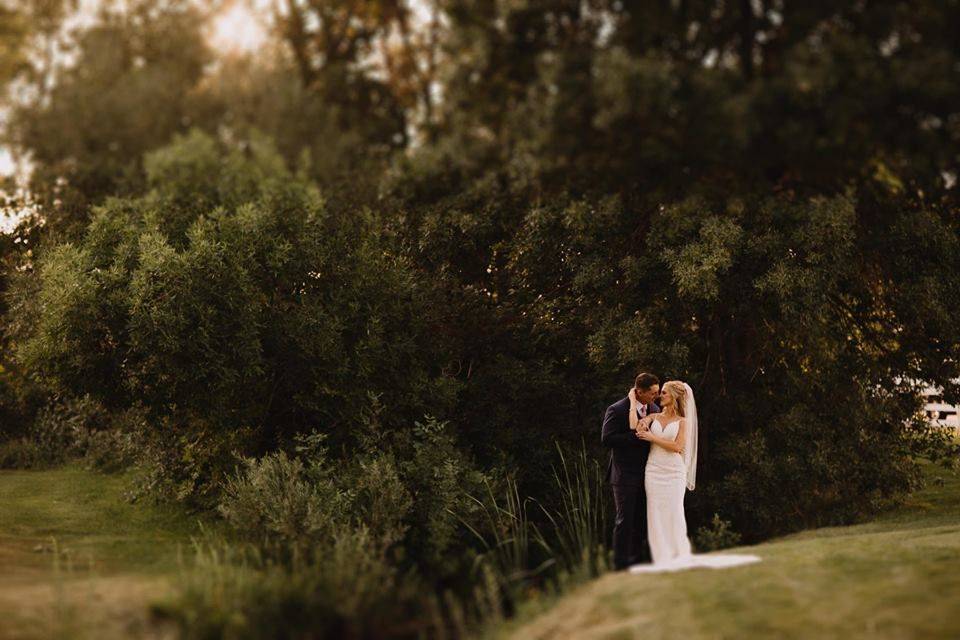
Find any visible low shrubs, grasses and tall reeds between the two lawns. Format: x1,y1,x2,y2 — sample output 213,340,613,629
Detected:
167,440,606,637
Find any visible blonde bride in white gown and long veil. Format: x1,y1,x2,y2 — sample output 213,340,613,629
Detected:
628,380,760,573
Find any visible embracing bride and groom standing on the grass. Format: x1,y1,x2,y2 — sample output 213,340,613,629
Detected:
600,373,759,573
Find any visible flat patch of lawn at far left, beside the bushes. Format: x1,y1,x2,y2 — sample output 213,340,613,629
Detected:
0,467,199,640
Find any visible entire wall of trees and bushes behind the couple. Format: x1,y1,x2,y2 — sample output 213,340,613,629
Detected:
0,0,960,635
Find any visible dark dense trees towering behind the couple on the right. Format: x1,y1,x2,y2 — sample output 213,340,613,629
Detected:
387,2,960,537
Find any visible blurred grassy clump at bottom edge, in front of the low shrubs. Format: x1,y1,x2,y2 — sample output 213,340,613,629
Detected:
158,529,418,639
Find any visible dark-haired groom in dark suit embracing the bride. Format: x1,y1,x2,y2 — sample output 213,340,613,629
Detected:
600,373,660,570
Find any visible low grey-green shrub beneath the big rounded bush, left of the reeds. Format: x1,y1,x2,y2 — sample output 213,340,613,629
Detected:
218,419,483,575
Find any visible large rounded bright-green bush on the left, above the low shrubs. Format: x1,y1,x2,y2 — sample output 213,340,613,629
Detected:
14,132,456,504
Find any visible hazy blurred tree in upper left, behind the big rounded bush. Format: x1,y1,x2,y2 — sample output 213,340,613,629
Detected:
6,0,210,238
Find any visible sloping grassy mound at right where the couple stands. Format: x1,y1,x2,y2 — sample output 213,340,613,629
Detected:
497,465,960,640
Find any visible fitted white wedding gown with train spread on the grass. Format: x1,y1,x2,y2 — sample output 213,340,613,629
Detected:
630,419,760,573
